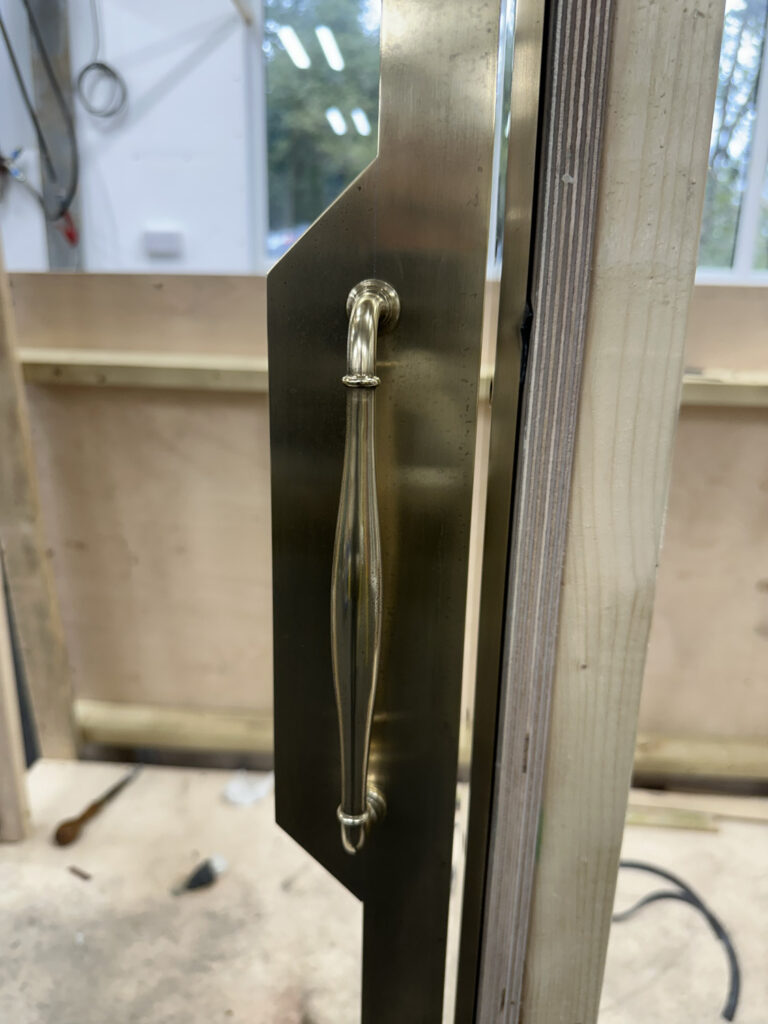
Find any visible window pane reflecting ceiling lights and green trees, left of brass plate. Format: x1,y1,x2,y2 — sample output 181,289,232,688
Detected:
264,0,380,259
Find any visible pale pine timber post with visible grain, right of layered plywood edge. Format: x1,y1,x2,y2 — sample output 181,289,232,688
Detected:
520,0,723,1024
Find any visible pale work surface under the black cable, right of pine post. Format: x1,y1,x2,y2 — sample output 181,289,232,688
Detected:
600,802,768,1024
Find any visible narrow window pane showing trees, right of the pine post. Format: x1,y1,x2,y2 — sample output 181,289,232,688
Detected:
700,0,768,267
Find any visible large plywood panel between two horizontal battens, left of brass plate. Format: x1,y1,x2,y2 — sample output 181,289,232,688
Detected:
29,387,271,712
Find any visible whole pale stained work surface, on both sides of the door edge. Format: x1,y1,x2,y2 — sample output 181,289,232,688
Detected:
0,762,768,1024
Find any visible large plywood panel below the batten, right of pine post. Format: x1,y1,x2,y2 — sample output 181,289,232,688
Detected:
641,409,768,746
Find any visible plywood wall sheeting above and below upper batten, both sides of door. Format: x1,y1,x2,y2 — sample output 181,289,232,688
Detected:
7,274,768,737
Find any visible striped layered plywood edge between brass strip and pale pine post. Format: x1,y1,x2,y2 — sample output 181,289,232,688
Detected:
477,0,612,1024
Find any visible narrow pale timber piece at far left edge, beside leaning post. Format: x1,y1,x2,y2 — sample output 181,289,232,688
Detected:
0,563,30,843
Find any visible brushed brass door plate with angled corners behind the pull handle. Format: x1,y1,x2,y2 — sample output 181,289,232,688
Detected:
268,0,501,1024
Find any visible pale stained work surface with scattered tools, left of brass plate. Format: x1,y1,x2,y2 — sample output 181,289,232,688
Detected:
0,762,362,1024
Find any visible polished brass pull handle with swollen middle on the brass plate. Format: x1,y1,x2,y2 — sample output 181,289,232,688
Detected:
331,281,400,853
